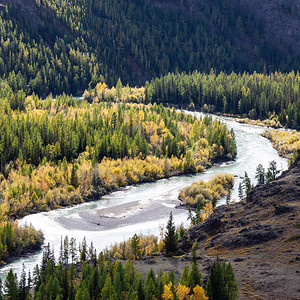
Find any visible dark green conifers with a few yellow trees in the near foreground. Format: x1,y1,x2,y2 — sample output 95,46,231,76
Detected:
0,215,238,300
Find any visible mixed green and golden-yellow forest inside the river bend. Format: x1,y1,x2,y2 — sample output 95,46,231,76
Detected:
0,87,236,220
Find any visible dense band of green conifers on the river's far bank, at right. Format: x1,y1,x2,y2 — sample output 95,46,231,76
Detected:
145,70,300,128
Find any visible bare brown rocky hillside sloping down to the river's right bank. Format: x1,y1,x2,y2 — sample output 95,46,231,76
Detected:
181,151,300,299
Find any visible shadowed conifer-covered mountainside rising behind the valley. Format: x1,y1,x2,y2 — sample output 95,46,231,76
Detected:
0,0,299,96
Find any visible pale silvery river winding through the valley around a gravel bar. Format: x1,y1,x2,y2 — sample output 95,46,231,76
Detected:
0,112,287,279
